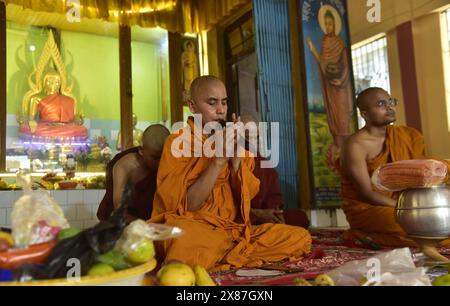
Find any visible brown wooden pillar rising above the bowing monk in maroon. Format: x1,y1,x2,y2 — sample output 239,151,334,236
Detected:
119,25,133,150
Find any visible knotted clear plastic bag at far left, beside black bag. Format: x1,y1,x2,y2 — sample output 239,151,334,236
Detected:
11,171,69,247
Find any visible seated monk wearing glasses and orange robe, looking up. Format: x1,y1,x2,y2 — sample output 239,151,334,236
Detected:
340,88,450,260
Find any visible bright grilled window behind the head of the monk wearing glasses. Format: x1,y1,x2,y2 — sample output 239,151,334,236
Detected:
352,36,390,127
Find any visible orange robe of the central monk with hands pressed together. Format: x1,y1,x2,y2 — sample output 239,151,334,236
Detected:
150,119,311,271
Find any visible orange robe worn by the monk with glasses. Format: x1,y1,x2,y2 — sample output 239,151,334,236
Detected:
342,126,425,247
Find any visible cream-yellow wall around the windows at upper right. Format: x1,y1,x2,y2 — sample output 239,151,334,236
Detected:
348,0,450,158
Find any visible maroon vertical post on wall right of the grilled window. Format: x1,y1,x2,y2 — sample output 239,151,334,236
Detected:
397,21,422,132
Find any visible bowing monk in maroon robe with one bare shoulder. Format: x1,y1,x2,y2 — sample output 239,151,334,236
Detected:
97,124,170,222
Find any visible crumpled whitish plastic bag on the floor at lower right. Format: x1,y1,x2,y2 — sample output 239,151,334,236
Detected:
327,248,431,286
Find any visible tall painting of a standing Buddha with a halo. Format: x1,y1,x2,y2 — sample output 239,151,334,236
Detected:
300,0,357,208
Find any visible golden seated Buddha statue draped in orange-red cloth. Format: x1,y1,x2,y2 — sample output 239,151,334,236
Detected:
19,72,87,139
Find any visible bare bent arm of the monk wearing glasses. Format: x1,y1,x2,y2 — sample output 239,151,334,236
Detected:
342,142,396,207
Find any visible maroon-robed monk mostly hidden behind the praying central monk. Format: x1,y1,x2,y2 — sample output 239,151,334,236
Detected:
241,114,309,228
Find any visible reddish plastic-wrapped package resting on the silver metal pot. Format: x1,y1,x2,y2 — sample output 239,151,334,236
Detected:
372,159,448,191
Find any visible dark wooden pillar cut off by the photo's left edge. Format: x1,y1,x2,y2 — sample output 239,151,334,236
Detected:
0,2,6,172
